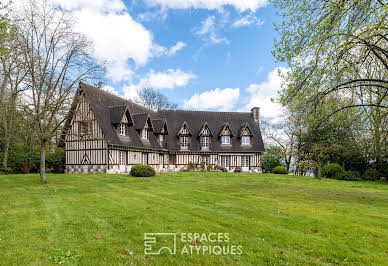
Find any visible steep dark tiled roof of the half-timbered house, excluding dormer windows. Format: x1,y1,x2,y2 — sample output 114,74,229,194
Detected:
61,83,265,152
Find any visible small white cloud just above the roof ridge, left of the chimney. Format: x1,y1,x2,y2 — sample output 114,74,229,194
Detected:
183,88,240,111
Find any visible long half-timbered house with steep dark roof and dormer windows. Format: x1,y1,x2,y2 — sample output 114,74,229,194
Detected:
61,83,264,173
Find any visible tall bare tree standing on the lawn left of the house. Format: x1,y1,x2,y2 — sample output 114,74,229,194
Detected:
12,0,102,183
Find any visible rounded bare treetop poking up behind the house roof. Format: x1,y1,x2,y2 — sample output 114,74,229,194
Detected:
137,88,177,111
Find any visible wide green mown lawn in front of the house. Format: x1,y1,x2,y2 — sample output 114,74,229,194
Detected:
0,173,388,265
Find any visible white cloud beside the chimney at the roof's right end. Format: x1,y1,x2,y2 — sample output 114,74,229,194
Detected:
239,67,289,121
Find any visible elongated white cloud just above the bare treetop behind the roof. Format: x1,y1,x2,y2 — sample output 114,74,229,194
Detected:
123,69,195,98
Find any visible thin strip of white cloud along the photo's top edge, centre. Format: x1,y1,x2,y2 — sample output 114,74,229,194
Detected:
146,0,269,12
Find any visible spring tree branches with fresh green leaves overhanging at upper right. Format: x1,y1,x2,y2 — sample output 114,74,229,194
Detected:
273,0,388,113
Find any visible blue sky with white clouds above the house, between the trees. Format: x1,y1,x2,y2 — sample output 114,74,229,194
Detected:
52,0,286,119
